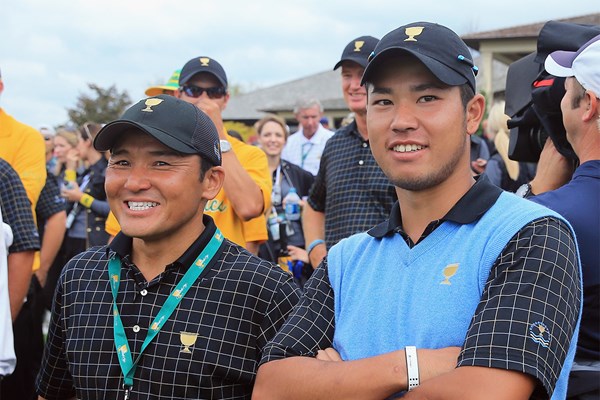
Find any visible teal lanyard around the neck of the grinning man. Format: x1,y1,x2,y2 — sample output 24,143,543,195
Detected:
108,229,223,397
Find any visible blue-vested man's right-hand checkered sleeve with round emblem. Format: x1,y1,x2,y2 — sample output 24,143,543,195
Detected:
458,217,581,398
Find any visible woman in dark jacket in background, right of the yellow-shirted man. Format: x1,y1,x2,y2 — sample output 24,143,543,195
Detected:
256,115,314,281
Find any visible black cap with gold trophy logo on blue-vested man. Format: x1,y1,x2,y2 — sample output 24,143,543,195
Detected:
362,22,478,92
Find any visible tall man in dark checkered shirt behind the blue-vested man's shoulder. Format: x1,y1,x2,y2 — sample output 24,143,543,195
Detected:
302,36,396,267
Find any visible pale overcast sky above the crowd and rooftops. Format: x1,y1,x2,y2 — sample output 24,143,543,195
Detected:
0,0,600,128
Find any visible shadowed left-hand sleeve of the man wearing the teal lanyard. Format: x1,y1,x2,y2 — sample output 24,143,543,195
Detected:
36,260,75,400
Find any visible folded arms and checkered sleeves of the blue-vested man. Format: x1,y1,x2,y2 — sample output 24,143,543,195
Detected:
253,218,580,400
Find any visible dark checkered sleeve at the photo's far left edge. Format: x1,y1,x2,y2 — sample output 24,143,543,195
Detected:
0,160,40,253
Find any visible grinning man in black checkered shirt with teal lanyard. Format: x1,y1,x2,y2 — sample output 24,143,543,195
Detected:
37,95,298,399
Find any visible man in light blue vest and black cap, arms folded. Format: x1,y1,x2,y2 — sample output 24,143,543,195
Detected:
254,22,581,400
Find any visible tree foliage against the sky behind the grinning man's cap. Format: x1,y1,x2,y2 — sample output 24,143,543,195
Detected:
67,83,131,126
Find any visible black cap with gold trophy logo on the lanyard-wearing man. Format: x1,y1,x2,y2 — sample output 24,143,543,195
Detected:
94,94,221,165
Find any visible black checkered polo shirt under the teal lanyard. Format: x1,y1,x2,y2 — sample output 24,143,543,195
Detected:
37,216,299,400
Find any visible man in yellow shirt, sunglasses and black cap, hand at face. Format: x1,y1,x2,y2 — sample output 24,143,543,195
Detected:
177,57,272,254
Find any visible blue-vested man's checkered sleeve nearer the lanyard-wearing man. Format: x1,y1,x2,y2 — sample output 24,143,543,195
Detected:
260,260,335,365
